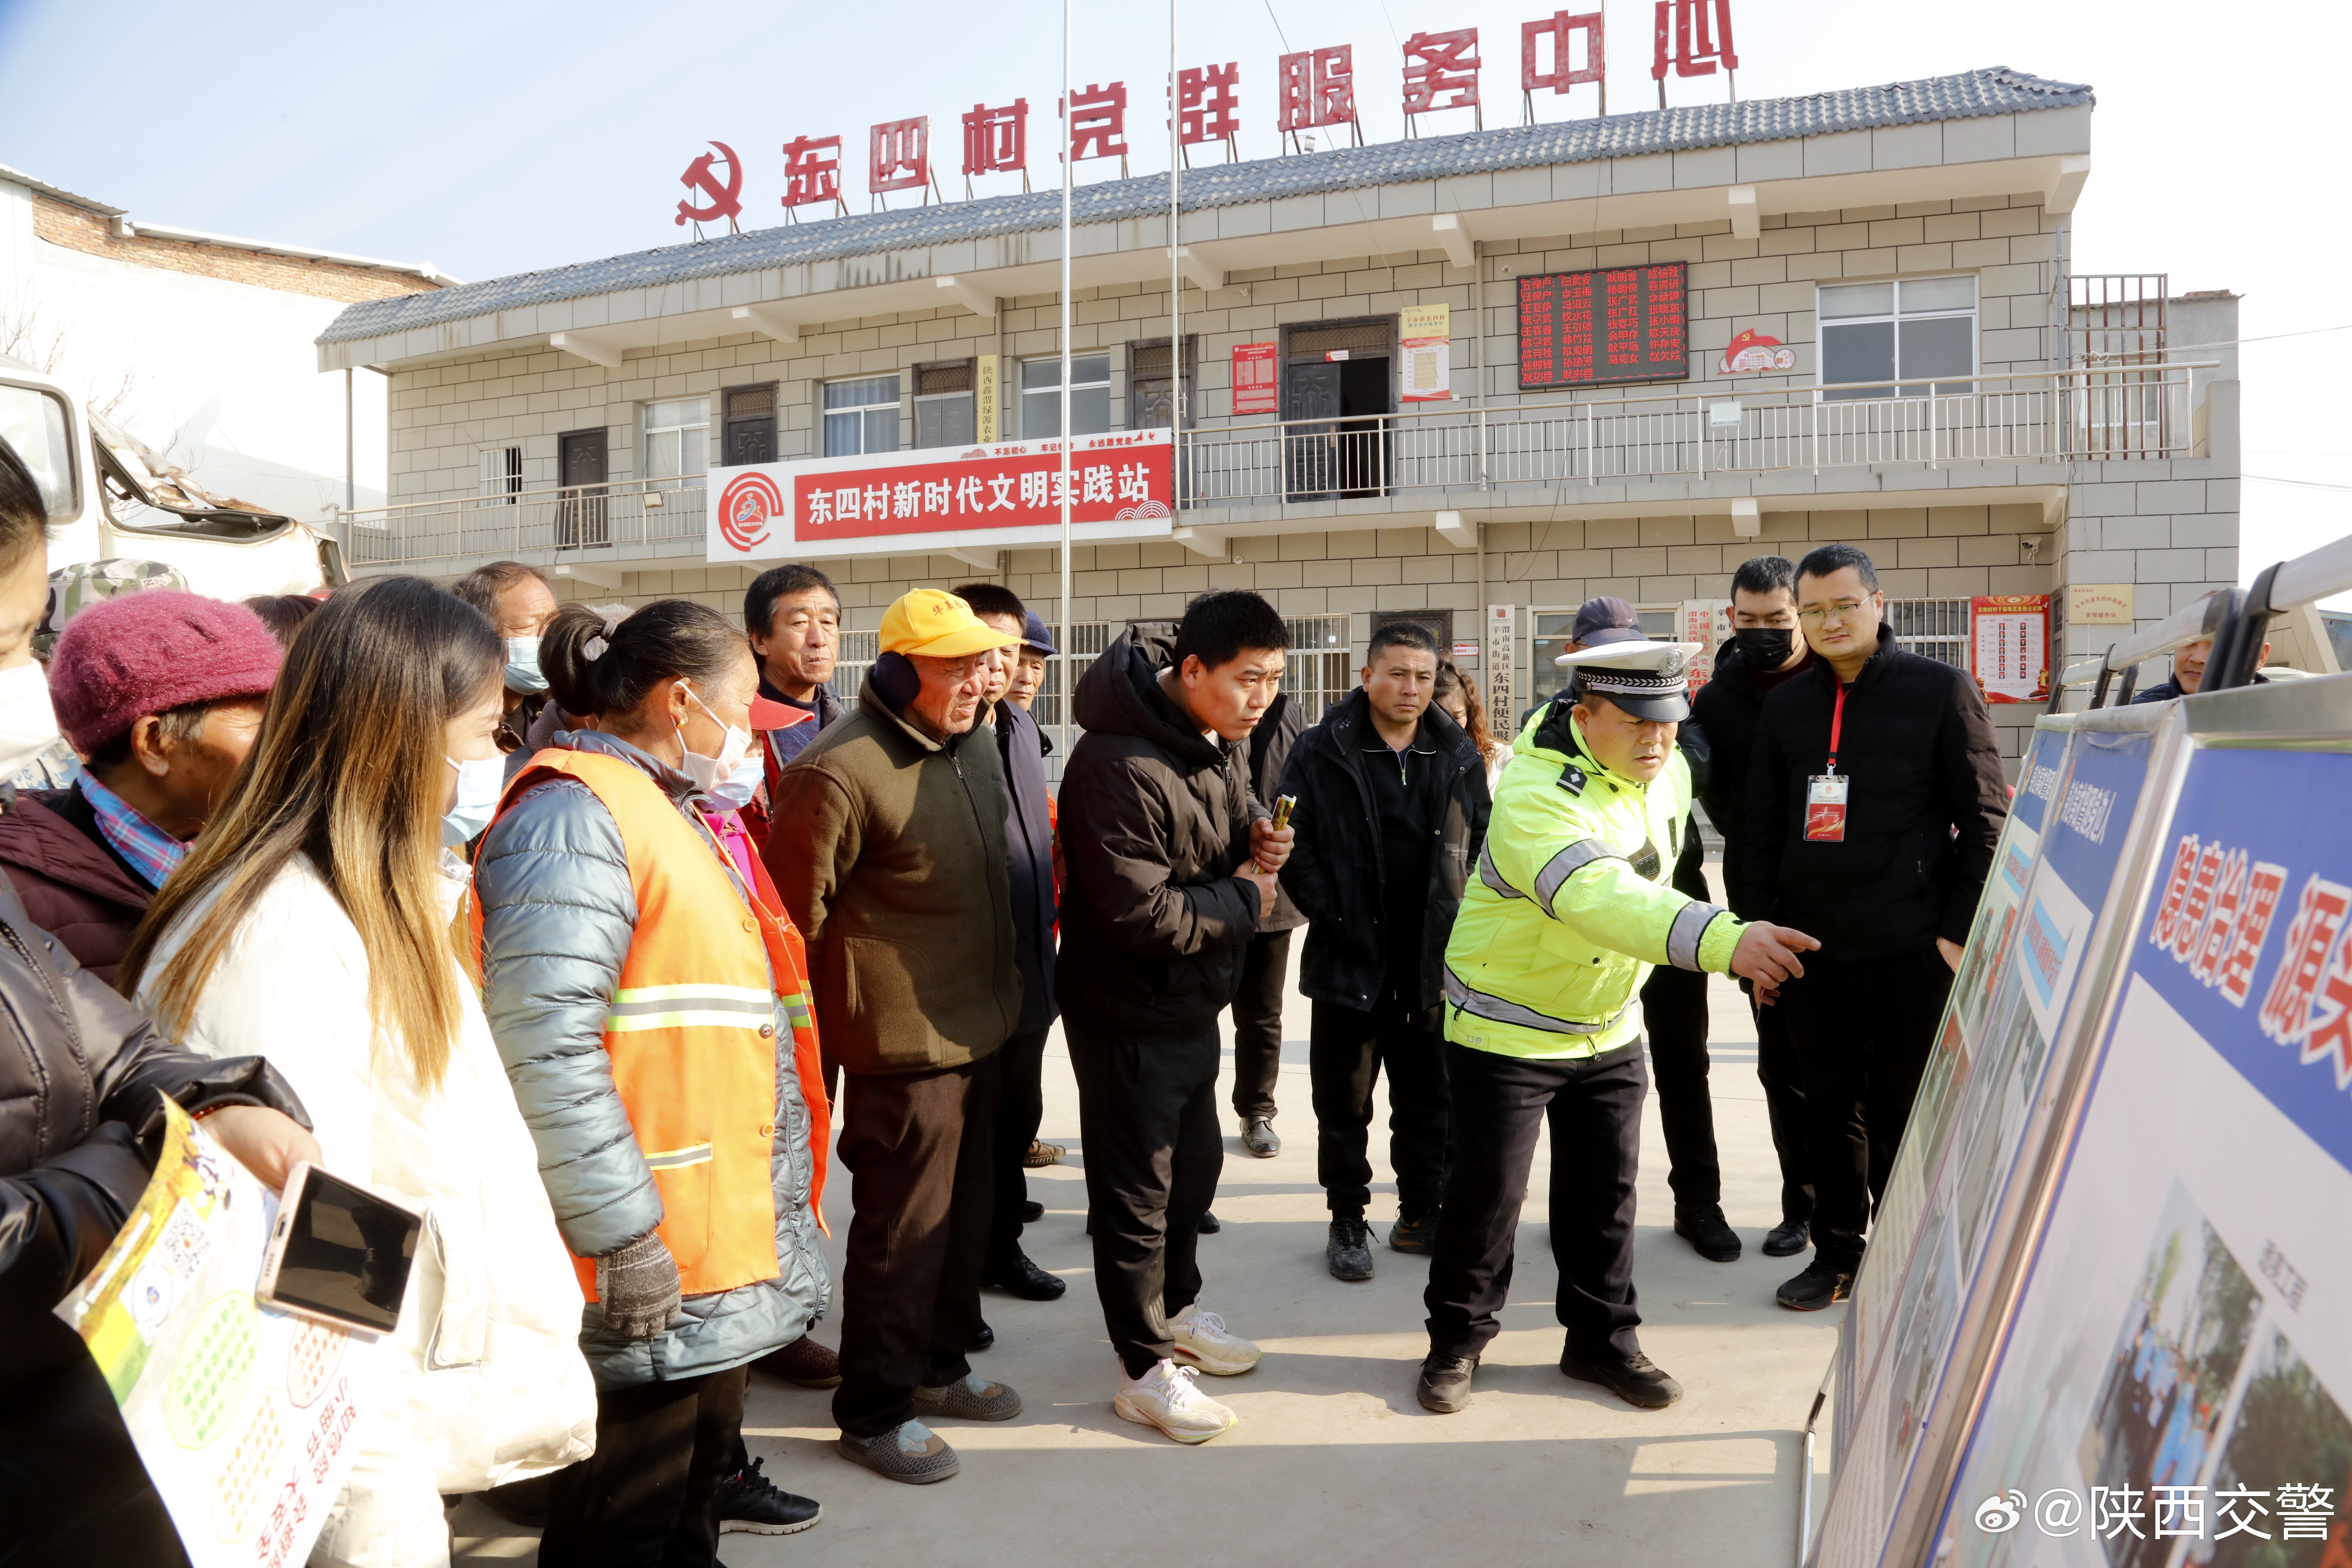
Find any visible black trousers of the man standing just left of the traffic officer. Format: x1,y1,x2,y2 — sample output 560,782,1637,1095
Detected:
1308,990,1446,1220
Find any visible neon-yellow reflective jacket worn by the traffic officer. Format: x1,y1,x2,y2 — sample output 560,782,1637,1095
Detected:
1446,703,1745,1058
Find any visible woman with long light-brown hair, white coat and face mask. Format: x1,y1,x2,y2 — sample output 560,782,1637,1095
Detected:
122,578,595,1568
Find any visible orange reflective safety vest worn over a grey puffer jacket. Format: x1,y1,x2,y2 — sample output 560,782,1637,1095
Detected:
473,748,833,1300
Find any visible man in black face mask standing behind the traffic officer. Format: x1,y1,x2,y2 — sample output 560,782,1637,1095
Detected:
1691,555,1813,1258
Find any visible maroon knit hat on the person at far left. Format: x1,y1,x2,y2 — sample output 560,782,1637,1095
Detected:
49,588,280,757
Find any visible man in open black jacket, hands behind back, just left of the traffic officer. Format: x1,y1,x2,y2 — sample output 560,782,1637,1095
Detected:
1282,621,1489,1281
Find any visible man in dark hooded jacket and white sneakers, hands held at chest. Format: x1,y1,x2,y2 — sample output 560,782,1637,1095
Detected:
1056,592,1291,1443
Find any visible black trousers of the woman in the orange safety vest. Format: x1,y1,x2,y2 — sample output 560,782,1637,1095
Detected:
539,1366,743,1568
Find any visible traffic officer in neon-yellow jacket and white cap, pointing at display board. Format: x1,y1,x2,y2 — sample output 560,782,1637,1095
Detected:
1416,639,1818,1413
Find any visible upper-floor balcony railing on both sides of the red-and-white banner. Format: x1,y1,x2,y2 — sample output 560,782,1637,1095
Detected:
346,362,2213,569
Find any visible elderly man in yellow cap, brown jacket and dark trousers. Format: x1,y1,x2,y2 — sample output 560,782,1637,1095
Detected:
762,588,1021,1483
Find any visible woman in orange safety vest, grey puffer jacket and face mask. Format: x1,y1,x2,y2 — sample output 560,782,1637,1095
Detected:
475,599,830,1568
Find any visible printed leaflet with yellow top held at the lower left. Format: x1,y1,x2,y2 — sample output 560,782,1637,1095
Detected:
56,1100,379,1568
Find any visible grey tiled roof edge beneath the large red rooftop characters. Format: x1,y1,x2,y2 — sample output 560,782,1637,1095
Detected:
318,66,2091,343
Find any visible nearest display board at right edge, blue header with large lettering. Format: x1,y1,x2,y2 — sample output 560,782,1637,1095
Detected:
1931,748,2352,1568
